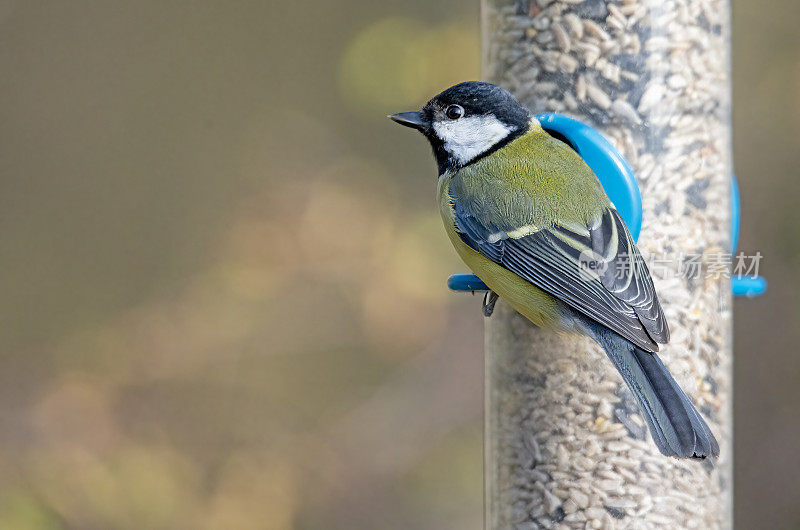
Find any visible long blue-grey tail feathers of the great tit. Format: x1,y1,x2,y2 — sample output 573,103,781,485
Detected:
593,326,719,459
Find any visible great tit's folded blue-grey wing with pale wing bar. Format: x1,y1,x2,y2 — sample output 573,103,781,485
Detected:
453,199,669,351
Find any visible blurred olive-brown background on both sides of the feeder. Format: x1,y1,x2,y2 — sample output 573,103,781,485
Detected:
0,0,800,530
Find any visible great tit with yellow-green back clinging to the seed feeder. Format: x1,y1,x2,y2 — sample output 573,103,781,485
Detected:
389,81,719,458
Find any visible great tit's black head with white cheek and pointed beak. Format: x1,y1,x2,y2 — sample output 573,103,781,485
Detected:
389,81,531,175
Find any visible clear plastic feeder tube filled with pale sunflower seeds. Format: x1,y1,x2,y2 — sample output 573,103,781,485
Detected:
483,0,733,529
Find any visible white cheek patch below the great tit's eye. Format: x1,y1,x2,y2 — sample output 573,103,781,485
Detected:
433,116,512,164
